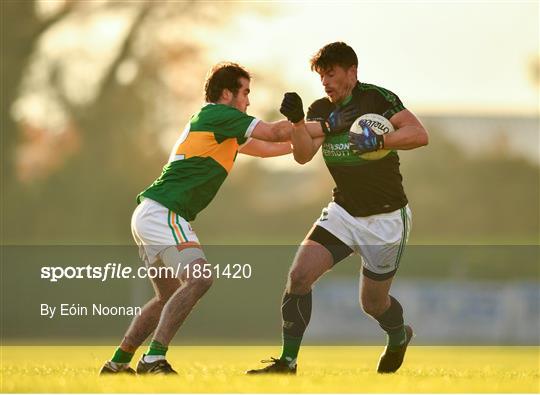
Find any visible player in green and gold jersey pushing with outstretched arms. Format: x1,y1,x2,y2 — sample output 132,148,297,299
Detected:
101,63,300,374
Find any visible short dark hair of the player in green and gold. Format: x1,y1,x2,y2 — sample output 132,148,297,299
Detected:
204,62,251,103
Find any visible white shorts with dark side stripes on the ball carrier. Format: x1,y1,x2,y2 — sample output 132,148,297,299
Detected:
315,202,412,274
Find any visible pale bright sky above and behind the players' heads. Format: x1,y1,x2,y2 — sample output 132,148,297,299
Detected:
205,1,540,115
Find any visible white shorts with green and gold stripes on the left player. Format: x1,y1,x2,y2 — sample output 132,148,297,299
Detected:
131,198,200,265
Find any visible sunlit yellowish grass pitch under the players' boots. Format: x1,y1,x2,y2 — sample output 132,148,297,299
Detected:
0,346,540,393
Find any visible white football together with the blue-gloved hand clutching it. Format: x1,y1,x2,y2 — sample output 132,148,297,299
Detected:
349,114,394,160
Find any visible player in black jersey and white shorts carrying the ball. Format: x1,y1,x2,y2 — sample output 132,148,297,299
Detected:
247,42,428,374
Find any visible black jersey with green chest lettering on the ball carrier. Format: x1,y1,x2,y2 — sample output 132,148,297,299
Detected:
307,82,407,217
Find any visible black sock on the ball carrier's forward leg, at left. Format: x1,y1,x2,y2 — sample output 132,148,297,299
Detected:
280,291,311,362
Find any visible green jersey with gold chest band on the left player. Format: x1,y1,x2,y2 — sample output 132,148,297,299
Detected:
137,103,259,221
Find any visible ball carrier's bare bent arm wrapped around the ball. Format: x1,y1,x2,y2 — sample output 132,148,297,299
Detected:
383,109,429,150
